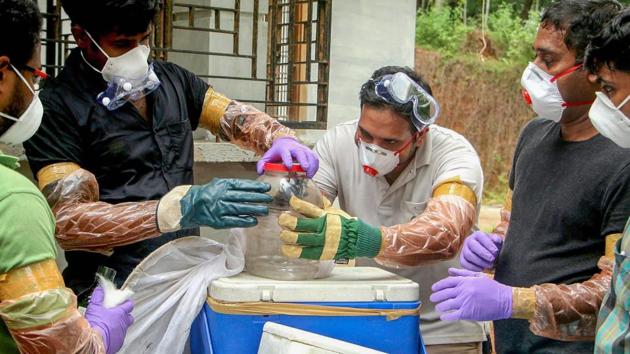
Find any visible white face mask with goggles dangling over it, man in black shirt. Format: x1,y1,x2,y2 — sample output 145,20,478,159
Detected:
81,31,160,111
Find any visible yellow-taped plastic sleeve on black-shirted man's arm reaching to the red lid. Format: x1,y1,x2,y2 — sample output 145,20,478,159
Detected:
200,88,295,155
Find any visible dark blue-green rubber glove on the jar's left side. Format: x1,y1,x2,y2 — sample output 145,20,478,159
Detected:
180,178,273,229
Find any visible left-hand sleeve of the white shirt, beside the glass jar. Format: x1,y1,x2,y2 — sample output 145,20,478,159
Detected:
313,130,338,202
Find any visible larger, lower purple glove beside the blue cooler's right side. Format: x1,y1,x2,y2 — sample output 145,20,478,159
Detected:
430,268,512,321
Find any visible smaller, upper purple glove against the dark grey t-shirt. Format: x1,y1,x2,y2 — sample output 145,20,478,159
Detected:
459,231,503,272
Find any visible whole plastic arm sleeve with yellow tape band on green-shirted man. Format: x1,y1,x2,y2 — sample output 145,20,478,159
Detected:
0,260,105,354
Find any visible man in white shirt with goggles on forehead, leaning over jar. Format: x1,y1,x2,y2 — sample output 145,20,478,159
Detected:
280,66,485,353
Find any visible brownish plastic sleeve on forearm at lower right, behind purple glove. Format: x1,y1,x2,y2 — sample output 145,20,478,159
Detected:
529,257,614,341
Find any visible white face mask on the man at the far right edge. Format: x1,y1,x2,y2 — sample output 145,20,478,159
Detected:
588,92,630,148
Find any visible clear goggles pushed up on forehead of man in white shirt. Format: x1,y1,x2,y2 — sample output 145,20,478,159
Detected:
374,72,440,131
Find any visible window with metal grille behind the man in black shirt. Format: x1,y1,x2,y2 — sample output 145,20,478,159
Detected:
42,0,332,129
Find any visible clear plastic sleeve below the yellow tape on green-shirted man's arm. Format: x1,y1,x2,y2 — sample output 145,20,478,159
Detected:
0,288,105,354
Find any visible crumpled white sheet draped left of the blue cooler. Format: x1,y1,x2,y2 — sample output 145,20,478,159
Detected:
119,236,245,354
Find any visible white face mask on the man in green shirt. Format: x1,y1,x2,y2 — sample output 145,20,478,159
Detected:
0,65,44,145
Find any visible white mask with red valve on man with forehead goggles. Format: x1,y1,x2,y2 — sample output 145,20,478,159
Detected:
359,135,415,177
